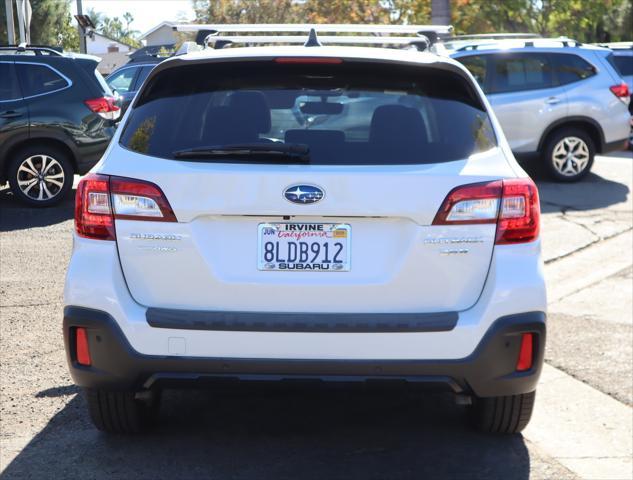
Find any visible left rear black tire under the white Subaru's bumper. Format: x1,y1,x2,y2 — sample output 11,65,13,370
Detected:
84,388,160,433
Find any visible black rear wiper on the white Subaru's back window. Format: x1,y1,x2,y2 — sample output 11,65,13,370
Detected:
172,143,310,161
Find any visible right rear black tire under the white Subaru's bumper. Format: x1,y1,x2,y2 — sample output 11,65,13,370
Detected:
470,392,536,433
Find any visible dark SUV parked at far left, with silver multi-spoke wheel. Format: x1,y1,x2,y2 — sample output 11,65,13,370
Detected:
0,47,121,206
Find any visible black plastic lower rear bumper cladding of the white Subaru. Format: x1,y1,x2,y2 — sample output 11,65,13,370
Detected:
64,306,545,397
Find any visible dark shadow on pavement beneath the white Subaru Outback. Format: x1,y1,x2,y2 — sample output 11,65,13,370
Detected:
4,389,530,480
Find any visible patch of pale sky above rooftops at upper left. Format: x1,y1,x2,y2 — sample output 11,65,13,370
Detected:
71,0,194,33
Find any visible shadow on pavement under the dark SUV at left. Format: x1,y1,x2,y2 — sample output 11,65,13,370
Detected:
0,188,75,232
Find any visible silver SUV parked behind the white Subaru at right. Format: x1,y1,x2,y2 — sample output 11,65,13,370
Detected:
451,39,630,182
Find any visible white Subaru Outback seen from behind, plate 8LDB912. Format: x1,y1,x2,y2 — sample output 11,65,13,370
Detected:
64,27,546,433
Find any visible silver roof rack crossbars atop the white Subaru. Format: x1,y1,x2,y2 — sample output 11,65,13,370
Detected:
172,23,453,50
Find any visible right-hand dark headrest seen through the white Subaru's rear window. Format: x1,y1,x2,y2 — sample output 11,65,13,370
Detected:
369,105,428,144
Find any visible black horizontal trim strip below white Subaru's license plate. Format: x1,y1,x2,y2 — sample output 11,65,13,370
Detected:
145,308,459,333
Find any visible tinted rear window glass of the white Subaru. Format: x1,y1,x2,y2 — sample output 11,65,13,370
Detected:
121,61,496,165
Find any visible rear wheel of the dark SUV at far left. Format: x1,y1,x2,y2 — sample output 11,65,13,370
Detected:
8,145,74,207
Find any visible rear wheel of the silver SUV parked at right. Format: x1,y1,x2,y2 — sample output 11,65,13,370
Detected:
543,128,596,182
